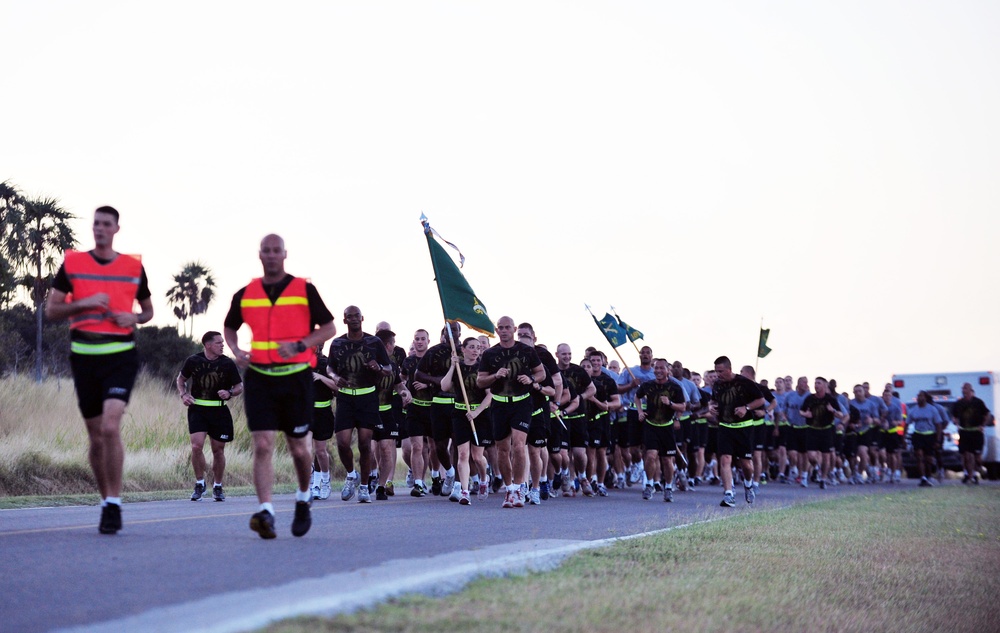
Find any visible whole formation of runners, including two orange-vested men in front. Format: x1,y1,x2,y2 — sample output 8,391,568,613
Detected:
46,214,985,539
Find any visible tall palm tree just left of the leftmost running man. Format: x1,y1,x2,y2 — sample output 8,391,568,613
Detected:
15,198,76,382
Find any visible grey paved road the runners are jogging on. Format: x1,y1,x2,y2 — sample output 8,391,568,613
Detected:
0,482,932,633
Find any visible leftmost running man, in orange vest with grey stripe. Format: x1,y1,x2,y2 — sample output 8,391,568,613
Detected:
45,207,153,534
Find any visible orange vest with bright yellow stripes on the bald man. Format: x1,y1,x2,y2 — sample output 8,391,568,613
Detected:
240,277,316,367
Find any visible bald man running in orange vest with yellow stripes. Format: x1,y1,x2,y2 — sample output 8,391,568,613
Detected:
224,234,337,539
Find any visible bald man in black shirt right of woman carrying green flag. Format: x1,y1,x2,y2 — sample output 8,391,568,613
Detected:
476,316,545,508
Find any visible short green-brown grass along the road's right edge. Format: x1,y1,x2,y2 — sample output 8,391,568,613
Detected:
267,486,1000,633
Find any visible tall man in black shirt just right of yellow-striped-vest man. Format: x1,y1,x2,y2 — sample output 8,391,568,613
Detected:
330,306,395,503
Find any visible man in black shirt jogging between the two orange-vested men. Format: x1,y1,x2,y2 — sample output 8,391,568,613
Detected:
176,332,243,501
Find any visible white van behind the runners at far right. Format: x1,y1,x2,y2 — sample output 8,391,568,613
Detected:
892,371,1000,479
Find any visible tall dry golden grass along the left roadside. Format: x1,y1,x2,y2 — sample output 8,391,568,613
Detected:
0,375,358,497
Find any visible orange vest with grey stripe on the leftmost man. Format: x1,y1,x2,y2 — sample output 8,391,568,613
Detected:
64,251,142,335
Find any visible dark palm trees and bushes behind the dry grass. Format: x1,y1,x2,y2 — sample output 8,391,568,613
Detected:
0,181,215,381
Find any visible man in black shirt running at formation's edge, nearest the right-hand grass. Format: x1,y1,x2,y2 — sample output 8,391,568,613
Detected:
712,356,764,508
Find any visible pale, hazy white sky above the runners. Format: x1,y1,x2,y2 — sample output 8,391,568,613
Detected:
0,0,1000,387
